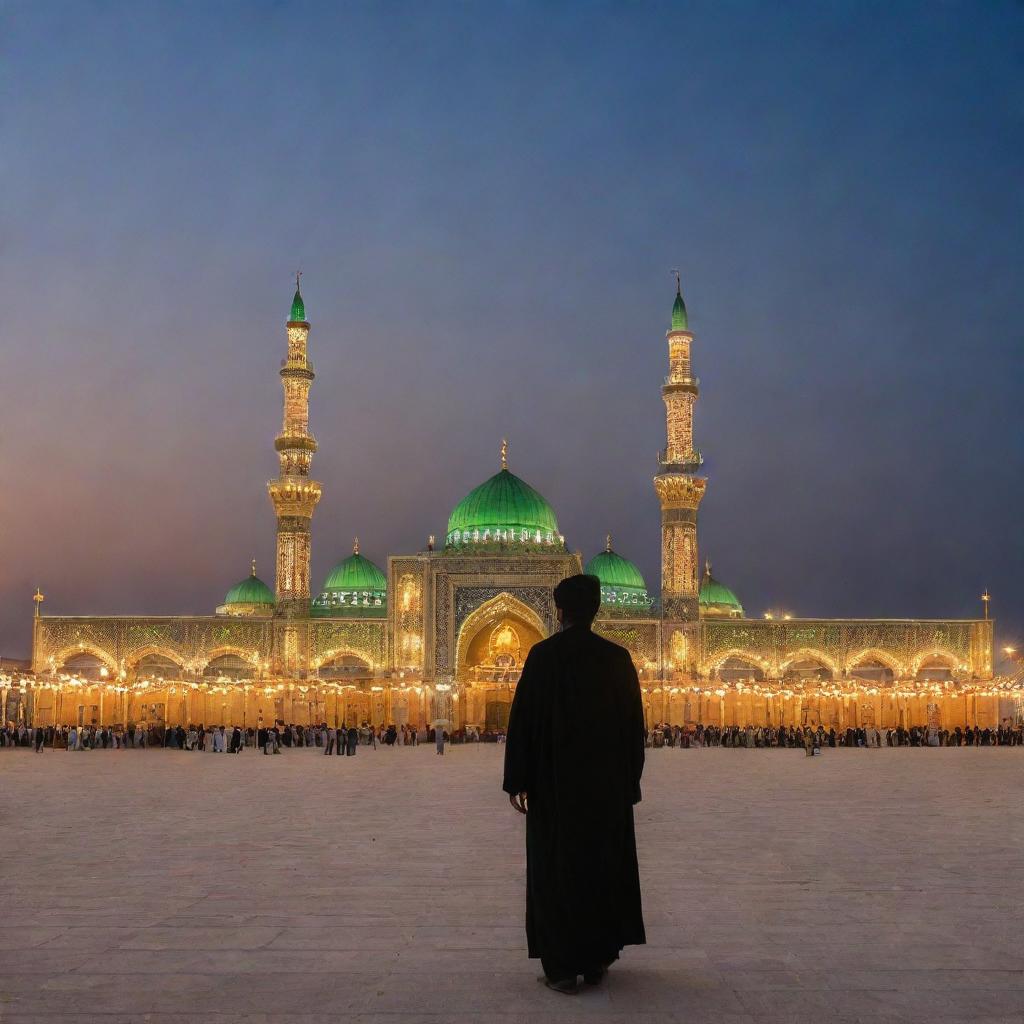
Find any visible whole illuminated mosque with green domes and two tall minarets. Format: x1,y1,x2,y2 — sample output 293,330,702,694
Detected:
31,279,1005,730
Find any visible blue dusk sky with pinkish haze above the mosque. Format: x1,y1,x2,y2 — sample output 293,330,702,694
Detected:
0,0,1024,657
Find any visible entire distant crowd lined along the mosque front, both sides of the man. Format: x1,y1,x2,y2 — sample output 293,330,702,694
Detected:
0,721,1024,757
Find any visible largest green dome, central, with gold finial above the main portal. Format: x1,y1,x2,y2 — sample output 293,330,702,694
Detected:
445,447,565,548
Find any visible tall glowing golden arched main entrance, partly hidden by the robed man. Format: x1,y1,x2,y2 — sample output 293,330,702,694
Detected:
453,593,547,732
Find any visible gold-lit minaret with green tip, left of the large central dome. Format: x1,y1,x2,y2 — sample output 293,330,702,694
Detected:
266,274,321,617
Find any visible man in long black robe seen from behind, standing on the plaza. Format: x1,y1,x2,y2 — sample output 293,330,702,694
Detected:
503,575,646,994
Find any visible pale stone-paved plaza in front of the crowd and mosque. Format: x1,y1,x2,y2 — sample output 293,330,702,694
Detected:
0,745,1024,1024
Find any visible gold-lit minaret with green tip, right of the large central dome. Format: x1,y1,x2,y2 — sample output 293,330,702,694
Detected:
654,273,708,623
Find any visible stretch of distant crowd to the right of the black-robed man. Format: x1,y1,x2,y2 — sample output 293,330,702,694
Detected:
648,721,1024,750
